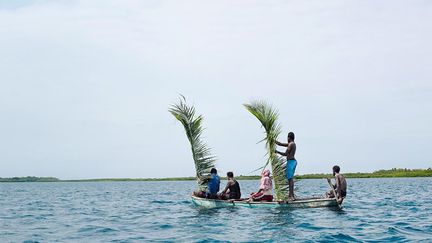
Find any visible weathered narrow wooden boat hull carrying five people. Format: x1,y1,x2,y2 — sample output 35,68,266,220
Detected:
192,196,339,208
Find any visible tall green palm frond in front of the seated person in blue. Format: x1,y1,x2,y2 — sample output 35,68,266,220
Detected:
169,96,215,191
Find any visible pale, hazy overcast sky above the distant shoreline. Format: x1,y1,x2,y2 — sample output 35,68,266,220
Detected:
0,0,432,179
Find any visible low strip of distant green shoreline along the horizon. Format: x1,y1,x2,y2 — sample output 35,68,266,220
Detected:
0,168,432,182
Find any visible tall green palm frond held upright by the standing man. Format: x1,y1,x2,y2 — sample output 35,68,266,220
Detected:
244,101,289,201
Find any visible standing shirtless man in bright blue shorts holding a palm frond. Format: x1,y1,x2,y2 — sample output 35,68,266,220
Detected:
275,132,297,200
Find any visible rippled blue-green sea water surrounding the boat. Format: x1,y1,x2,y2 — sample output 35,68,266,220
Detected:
0,178,432,242
